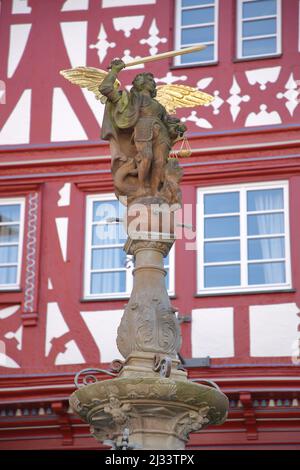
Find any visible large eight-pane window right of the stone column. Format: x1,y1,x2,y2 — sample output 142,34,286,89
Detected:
197,182,291,293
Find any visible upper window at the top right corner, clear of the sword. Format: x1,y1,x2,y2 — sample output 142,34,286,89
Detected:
237,0,281,58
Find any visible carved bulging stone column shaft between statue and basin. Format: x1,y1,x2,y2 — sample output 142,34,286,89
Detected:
117,238,181,375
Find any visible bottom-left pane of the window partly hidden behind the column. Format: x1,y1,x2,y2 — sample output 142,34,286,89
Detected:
91,271,126,294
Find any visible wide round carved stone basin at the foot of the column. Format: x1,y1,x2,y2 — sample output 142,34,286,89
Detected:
70,374,228,449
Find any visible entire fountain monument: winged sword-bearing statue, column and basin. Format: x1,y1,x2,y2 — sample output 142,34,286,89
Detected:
60,45,228,450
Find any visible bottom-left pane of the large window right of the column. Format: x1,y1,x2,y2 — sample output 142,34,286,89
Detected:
204,265,241,287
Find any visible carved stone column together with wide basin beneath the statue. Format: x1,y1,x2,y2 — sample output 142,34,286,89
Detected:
70,206,228,450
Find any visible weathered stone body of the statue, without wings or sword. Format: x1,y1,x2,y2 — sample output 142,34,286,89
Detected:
99,59,186,205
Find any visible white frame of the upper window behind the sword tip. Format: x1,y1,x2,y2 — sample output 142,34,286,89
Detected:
174,0,219,67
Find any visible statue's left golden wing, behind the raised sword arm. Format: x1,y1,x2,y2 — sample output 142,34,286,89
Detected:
60,67,121,103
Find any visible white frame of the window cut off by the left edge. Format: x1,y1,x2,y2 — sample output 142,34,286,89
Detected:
0,197,25,291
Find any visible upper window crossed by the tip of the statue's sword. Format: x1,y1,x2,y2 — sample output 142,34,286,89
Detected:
174,0,218,65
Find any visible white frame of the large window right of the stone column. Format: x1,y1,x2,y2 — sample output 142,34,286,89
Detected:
197,181,292,295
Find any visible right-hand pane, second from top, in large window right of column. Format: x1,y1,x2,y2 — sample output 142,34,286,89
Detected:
248,214,284,235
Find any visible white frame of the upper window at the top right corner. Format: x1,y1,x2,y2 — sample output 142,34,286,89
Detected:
237,0,282,59
